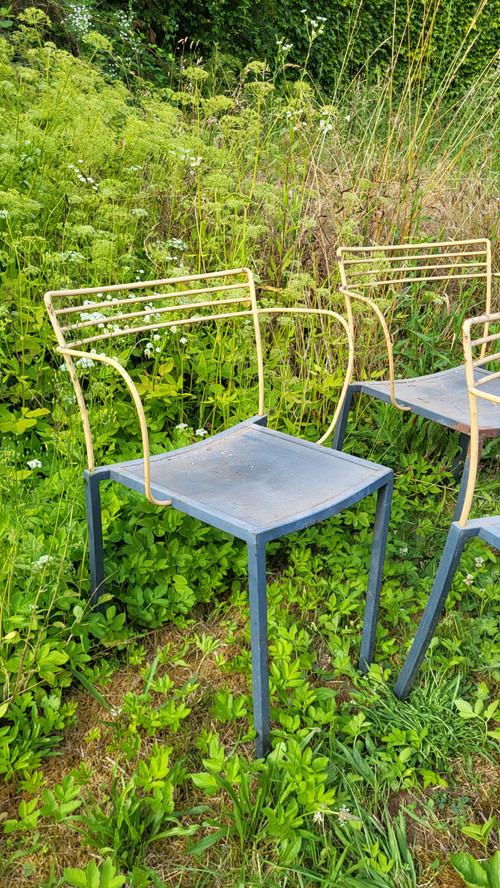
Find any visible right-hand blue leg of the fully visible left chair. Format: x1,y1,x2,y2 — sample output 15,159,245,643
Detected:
359,478,393,672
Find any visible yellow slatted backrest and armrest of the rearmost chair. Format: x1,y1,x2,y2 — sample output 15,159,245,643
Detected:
337,238,492,409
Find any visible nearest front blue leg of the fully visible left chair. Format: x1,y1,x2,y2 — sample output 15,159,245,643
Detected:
248,542,271,758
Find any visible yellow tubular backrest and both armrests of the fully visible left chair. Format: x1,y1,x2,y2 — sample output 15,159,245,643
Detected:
45,268,354,505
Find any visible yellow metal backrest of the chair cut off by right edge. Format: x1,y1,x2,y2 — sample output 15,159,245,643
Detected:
459,314,500,527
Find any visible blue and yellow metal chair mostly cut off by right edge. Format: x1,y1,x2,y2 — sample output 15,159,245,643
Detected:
394,314,500,700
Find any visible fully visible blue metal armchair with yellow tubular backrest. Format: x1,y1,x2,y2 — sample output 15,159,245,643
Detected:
45,269,393,758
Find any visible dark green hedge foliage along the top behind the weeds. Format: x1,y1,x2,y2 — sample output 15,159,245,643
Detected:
57,0,500,93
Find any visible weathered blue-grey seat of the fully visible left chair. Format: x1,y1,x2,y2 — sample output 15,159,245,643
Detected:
93,417,391,542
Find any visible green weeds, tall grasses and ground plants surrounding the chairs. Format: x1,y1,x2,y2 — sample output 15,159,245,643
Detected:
0,0,500,888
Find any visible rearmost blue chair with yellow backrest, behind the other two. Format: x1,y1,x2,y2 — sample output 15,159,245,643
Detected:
332,239,500,518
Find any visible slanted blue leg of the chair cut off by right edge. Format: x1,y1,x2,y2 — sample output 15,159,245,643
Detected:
394,523,477,700
